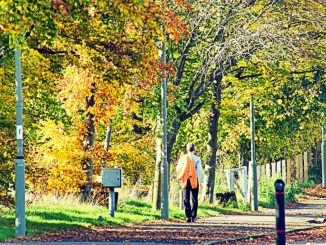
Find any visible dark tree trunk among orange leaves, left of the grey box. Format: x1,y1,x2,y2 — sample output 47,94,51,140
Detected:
83,84,95,200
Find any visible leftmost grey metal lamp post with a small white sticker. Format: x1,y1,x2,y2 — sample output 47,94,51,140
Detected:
15,49,26,236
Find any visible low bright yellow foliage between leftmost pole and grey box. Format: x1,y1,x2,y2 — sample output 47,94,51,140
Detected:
27,121,85,194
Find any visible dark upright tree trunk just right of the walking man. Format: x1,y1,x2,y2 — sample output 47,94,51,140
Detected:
203,76,222,203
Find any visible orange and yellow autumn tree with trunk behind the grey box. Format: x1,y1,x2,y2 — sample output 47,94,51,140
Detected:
1,0,166,199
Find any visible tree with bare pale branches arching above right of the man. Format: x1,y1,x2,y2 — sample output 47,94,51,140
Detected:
161,1,323,201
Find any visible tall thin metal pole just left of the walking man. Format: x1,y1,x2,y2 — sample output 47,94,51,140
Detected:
161,42,169,220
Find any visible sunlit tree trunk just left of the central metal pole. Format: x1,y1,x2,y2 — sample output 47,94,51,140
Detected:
152,118,163,210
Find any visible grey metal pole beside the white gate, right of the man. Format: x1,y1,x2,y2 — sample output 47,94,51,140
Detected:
250,95,258,211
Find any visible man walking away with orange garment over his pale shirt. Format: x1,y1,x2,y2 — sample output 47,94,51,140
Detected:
177,143,204,222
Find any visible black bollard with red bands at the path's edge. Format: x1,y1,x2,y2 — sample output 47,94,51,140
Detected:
274,179,286,245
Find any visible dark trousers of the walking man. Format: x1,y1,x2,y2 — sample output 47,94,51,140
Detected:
183,180,199,219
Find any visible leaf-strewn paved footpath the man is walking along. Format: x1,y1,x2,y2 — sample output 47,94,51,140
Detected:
0,198,326,245
